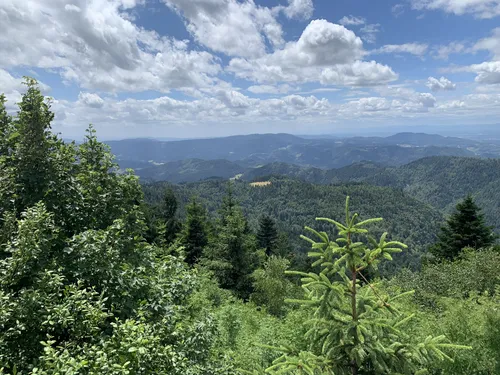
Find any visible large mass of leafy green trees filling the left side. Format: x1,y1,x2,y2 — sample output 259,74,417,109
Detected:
0,79,234,375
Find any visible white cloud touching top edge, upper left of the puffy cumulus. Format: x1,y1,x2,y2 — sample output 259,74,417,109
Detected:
163,0,284,57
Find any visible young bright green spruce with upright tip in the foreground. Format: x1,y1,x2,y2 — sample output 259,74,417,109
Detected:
266,197,465,375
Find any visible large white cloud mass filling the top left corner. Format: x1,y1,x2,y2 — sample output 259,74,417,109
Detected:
0,0,220,92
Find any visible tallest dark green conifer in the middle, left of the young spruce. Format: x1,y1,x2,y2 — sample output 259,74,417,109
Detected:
203,188,258,299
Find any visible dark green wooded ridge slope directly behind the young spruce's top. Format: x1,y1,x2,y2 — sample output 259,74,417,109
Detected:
143,178,443,268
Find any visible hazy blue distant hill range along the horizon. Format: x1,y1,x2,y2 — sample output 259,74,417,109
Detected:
107,133,500,169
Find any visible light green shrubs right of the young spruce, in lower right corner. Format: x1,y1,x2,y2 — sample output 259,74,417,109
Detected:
388,249,500,375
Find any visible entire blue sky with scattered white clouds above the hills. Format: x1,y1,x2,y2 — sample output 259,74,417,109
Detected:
0,0,500,139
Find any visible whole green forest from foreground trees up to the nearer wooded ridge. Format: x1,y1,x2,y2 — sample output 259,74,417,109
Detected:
0,78,500,375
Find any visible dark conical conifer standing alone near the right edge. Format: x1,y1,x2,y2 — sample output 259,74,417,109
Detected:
430,195,496,260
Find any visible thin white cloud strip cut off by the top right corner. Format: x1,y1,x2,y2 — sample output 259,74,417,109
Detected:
411,0,500,18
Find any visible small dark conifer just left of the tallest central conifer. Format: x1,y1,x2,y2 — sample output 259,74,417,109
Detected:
180,198,208,266
